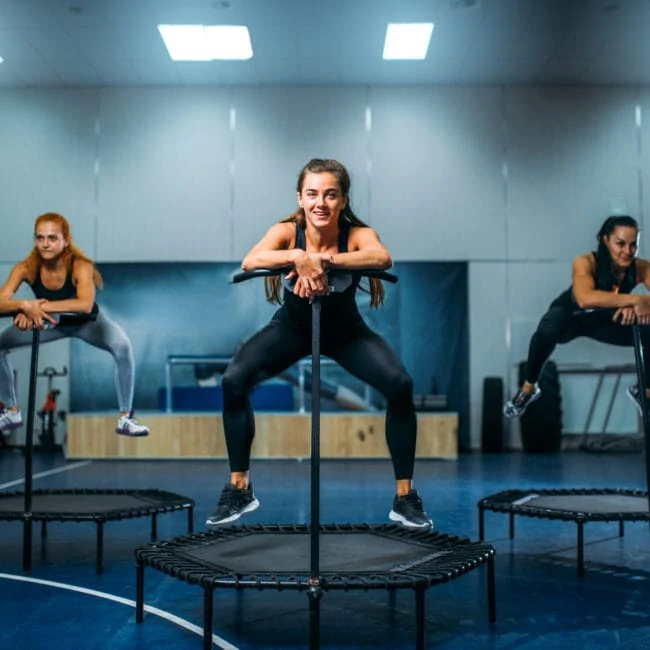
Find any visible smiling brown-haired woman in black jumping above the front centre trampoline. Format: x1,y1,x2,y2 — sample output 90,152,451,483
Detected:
206,159,432,528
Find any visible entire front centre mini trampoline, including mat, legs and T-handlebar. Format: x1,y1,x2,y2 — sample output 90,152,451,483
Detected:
135,269,496,650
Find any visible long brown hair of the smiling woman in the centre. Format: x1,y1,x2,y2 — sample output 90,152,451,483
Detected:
265,158,385,307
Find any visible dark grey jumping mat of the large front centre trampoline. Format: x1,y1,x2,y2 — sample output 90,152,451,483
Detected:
179,532,449,574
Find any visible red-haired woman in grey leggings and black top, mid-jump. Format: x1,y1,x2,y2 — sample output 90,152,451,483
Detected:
0,212,149,436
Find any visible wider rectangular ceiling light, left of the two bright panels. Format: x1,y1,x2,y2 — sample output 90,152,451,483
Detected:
158,25,253,61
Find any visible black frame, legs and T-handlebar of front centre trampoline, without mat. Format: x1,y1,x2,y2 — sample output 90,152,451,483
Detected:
136,268,496,650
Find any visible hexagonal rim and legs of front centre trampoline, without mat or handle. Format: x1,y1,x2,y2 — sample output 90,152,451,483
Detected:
135,524,496,650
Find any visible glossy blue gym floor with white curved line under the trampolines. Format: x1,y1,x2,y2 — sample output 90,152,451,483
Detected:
0,450,650,650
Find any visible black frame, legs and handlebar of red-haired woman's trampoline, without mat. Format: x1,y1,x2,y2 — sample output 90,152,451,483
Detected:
0,312,195,574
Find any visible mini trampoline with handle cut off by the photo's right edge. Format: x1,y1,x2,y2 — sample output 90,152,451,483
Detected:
477,309,650,576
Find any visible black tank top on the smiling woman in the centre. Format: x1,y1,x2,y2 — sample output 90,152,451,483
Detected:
276,221,361,329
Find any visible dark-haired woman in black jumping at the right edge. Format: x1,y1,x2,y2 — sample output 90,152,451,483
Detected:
503,216,650,418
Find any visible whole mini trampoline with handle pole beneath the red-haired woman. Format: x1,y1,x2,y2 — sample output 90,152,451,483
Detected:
0,314,195,573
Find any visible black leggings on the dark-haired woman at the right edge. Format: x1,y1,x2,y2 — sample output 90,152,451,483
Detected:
526,305,650,387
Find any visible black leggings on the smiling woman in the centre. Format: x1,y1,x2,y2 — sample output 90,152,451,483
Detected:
222,320,417,479
